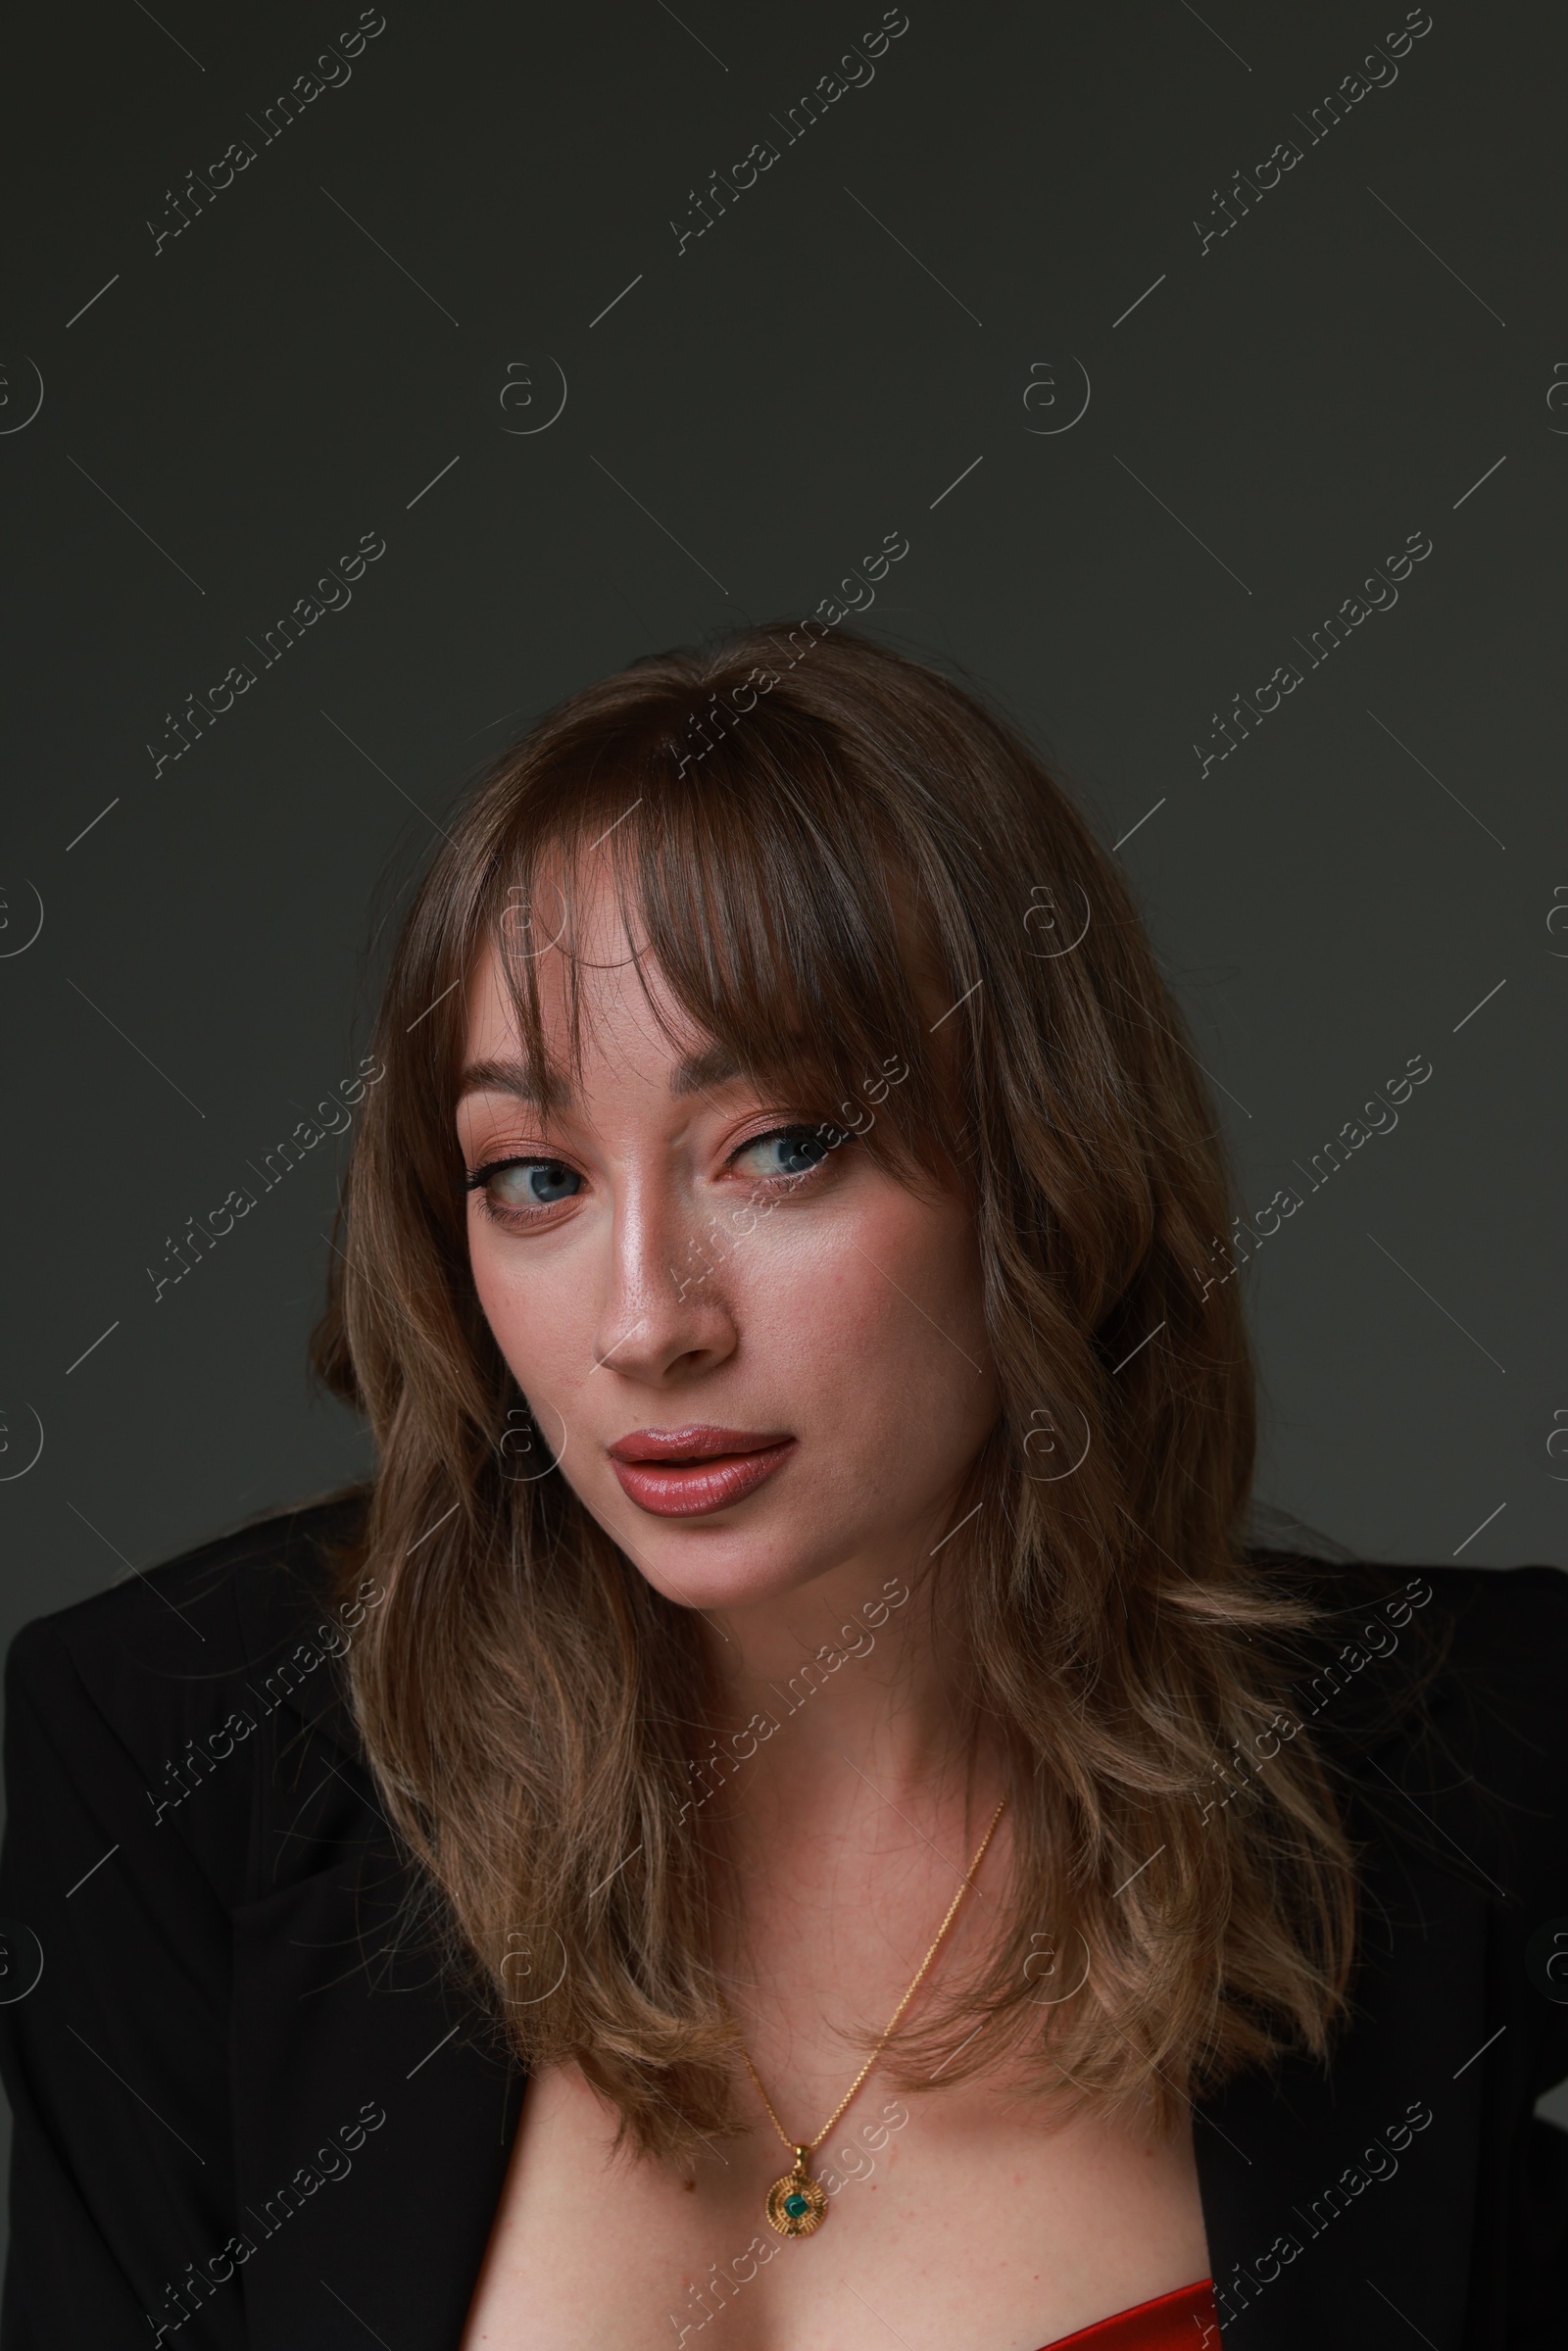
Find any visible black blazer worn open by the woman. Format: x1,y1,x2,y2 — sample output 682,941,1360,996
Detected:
0,1500,1568,2351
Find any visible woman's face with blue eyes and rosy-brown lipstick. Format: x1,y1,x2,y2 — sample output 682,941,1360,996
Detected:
459,874,997,1608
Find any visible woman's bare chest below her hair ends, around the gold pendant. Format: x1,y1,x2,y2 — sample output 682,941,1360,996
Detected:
461,2067,1208,2351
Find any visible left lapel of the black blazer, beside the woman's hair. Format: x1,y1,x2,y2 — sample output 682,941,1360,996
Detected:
226,1560,524,2351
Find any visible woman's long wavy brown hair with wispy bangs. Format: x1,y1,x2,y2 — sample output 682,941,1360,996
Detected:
318,623,1354,2156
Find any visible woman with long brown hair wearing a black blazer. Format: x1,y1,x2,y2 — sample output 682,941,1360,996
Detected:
0,623,1568,2351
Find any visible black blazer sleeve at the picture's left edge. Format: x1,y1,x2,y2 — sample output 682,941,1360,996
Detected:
0,1622,244,2351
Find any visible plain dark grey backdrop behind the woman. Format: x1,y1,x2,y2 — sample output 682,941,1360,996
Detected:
0,0,1568,2247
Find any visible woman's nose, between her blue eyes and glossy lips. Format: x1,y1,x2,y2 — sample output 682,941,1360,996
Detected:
588,1185,741,1387
